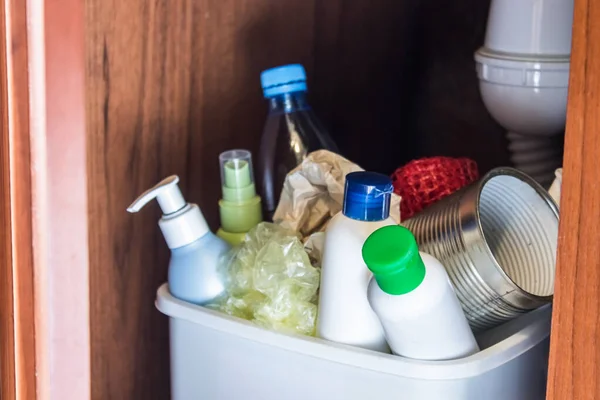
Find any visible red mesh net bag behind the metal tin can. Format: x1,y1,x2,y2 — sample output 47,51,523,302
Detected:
392,157,479,220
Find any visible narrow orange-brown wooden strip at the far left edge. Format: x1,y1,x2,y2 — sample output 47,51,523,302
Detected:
0,0,36,400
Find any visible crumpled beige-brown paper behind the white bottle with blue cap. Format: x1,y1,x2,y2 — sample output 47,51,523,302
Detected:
273,150,401,241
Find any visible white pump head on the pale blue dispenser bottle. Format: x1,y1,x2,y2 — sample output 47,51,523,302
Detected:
127,175,209,249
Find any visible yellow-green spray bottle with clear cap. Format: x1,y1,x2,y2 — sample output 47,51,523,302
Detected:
217,150,262,246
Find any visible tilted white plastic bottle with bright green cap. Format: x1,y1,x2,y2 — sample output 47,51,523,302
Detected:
362,226,479,360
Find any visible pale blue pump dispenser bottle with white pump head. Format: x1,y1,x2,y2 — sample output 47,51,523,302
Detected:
127,175,229,304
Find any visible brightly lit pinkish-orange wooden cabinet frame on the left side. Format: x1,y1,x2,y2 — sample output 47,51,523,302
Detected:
0,0,89,400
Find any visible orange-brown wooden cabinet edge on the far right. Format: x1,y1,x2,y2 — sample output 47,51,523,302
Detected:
548,0,600,400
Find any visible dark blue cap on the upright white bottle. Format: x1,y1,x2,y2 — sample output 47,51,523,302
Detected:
342,171,394,221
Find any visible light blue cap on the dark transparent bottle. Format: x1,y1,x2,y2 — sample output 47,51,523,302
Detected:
260,64,306,99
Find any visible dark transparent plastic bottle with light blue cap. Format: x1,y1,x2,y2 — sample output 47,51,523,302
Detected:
258,64,338,220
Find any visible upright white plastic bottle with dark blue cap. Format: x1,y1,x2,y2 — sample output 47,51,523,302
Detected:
317,172,396,353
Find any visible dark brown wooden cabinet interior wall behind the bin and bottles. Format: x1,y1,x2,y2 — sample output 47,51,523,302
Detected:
86,0,507,400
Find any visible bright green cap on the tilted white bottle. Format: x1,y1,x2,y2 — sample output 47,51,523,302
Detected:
362,225,425,295
